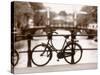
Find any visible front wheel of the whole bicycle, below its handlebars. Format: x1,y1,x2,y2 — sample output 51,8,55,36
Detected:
32,44,52,66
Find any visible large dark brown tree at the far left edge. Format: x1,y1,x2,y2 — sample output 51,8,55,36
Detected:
14,1,34,34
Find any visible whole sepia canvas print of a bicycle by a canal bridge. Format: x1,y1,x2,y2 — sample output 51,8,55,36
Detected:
11,1,98,74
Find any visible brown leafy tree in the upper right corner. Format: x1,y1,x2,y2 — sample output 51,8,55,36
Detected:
77,6,97,27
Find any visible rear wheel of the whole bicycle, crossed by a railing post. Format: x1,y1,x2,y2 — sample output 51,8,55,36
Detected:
64,43,83,64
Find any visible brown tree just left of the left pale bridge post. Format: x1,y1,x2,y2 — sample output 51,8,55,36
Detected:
30,2,46,26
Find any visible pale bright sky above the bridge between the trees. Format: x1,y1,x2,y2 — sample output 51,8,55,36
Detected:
44,3,83,13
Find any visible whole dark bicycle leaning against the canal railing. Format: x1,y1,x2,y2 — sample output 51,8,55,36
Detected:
32,26,83,66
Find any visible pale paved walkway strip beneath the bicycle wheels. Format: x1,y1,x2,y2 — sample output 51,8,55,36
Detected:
14,63,97,74
